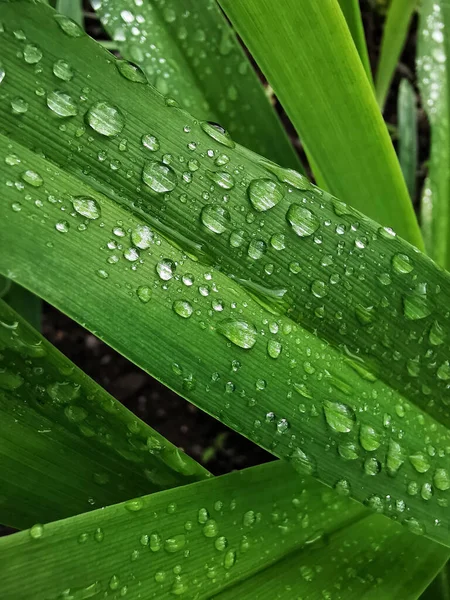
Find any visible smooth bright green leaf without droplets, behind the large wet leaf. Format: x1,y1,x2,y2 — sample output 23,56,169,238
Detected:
221,0,422,248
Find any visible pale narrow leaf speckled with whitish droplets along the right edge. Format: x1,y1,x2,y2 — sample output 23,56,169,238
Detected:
417,0,450,268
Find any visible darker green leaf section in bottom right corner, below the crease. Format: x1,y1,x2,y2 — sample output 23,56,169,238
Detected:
215,515,449,600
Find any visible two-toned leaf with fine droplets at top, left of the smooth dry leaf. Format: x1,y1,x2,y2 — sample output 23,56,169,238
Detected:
92,0,301,169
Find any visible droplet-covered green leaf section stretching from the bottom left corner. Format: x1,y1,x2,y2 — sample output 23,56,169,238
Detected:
0,461,365,600
